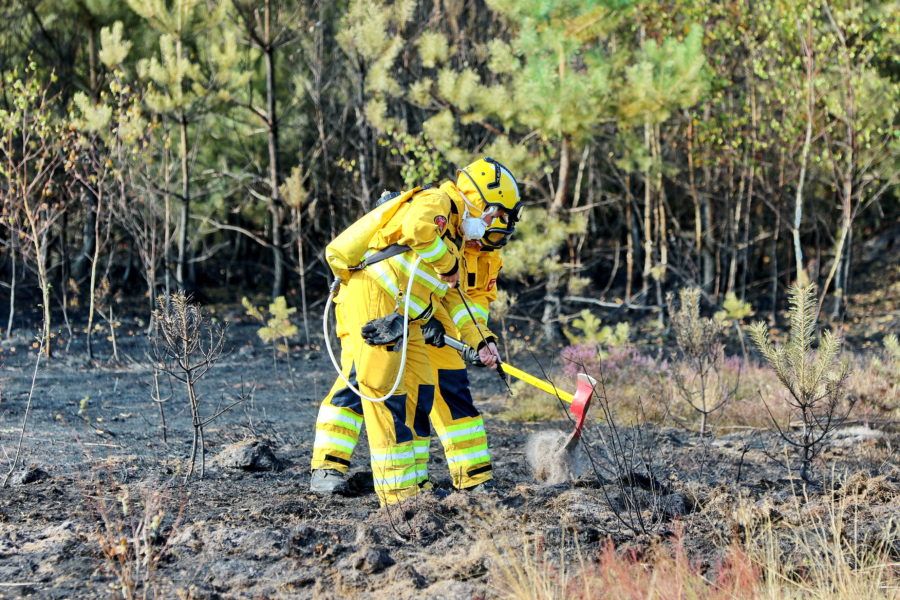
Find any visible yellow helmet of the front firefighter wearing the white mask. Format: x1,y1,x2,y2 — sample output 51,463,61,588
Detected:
456,157,522,223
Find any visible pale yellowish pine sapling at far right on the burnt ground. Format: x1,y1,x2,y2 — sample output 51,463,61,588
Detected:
750,284,854,482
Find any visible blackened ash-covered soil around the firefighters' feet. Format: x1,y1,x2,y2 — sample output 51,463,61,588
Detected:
0,325,900,598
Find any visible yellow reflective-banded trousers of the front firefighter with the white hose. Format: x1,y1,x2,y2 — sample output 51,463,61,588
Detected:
312,271,434,505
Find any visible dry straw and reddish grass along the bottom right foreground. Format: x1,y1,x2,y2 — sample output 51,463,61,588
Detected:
491,488,900,600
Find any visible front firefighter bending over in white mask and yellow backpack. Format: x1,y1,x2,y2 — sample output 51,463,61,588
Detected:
311,159,521,504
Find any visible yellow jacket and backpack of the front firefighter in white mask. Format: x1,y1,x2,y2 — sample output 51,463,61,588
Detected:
325,183,487,347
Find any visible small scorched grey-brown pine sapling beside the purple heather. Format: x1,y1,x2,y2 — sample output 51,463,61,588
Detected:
667,288,739,436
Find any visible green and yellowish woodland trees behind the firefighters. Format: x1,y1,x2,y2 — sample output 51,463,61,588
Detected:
0,0,900,338
